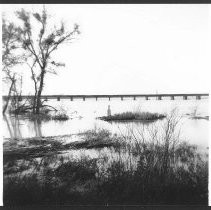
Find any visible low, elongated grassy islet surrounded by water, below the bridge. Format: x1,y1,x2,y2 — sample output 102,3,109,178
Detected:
99,112,166,121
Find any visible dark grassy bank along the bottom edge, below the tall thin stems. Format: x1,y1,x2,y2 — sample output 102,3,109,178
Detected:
4,141,208,205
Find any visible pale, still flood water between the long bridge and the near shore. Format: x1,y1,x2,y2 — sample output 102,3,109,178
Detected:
3,98,209,149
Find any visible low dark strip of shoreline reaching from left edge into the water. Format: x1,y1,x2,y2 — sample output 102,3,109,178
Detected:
3,132,120,162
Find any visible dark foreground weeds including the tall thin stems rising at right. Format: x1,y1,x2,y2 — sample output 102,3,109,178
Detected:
4,110,208,205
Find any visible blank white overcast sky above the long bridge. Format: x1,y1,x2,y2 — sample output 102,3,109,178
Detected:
2,4,211,94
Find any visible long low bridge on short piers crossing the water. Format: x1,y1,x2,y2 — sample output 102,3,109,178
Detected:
3,93,209,101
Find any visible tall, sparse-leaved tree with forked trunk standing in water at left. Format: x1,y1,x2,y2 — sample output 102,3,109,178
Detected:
16,8,79,114
